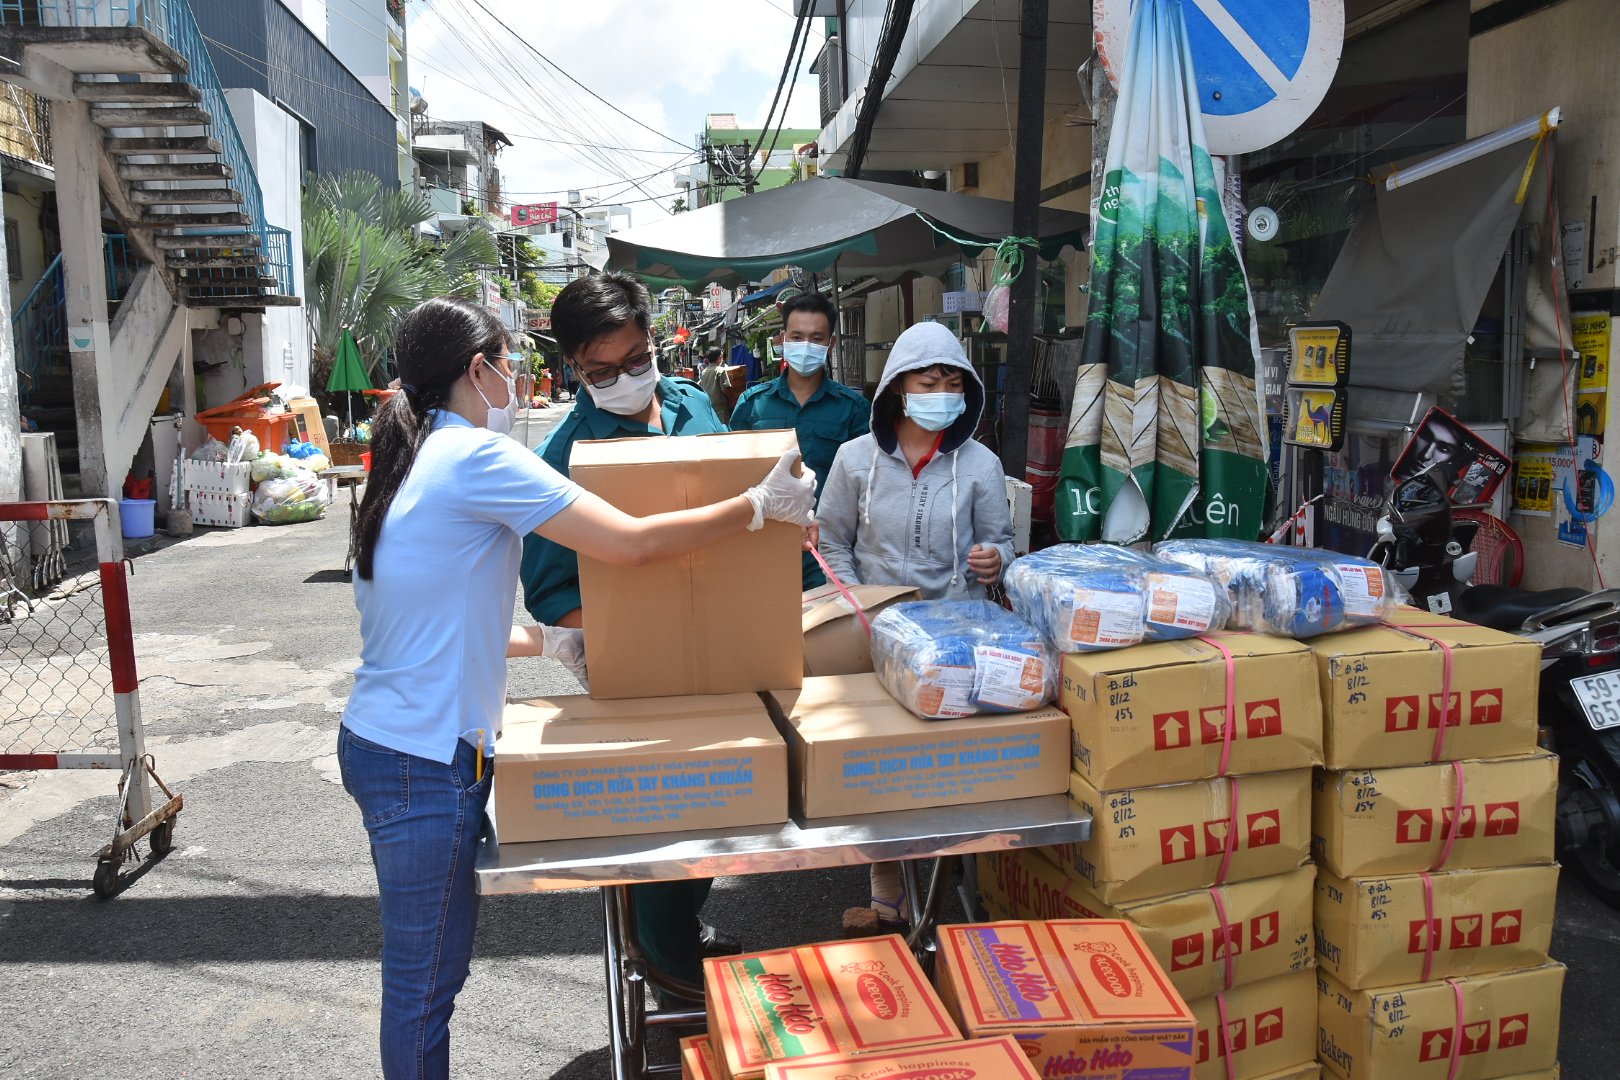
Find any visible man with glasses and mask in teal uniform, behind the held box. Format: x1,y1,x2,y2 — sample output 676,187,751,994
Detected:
522,274,740,986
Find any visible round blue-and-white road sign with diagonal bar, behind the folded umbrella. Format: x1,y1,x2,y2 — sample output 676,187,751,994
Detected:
1094,0,1345,154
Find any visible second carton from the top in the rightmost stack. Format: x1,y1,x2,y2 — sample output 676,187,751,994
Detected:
1312,753,1558,878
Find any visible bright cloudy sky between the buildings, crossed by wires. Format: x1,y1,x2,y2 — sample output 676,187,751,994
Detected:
407,0,821,223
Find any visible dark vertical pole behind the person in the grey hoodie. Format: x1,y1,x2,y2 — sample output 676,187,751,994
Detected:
1001,0,1047,479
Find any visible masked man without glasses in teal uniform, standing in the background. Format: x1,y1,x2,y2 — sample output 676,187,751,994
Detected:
729,293,872,589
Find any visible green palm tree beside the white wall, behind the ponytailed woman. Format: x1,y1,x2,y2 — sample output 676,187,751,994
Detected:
303,172,497,387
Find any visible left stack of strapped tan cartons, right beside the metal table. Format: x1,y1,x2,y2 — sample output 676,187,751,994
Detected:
978,635,1322,1080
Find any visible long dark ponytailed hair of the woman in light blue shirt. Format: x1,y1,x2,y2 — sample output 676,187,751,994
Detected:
355,296,510,581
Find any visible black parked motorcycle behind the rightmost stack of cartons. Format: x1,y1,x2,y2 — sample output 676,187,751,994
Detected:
1369,474,1620,908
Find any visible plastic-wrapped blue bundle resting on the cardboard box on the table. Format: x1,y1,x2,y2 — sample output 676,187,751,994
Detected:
872,601,1058,721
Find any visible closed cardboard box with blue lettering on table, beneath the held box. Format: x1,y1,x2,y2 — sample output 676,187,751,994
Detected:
494,693,787,842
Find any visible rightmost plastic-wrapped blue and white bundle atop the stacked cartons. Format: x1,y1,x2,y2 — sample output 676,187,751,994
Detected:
1153,539,1400,638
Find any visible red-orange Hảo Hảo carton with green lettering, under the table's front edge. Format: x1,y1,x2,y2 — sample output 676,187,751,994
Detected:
703,934,962,1080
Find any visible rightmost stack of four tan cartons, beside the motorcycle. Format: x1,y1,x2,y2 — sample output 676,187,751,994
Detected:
1312,609,1563,1080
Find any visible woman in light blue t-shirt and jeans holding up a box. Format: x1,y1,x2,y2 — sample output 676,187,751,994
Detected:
337,296,813,1080
